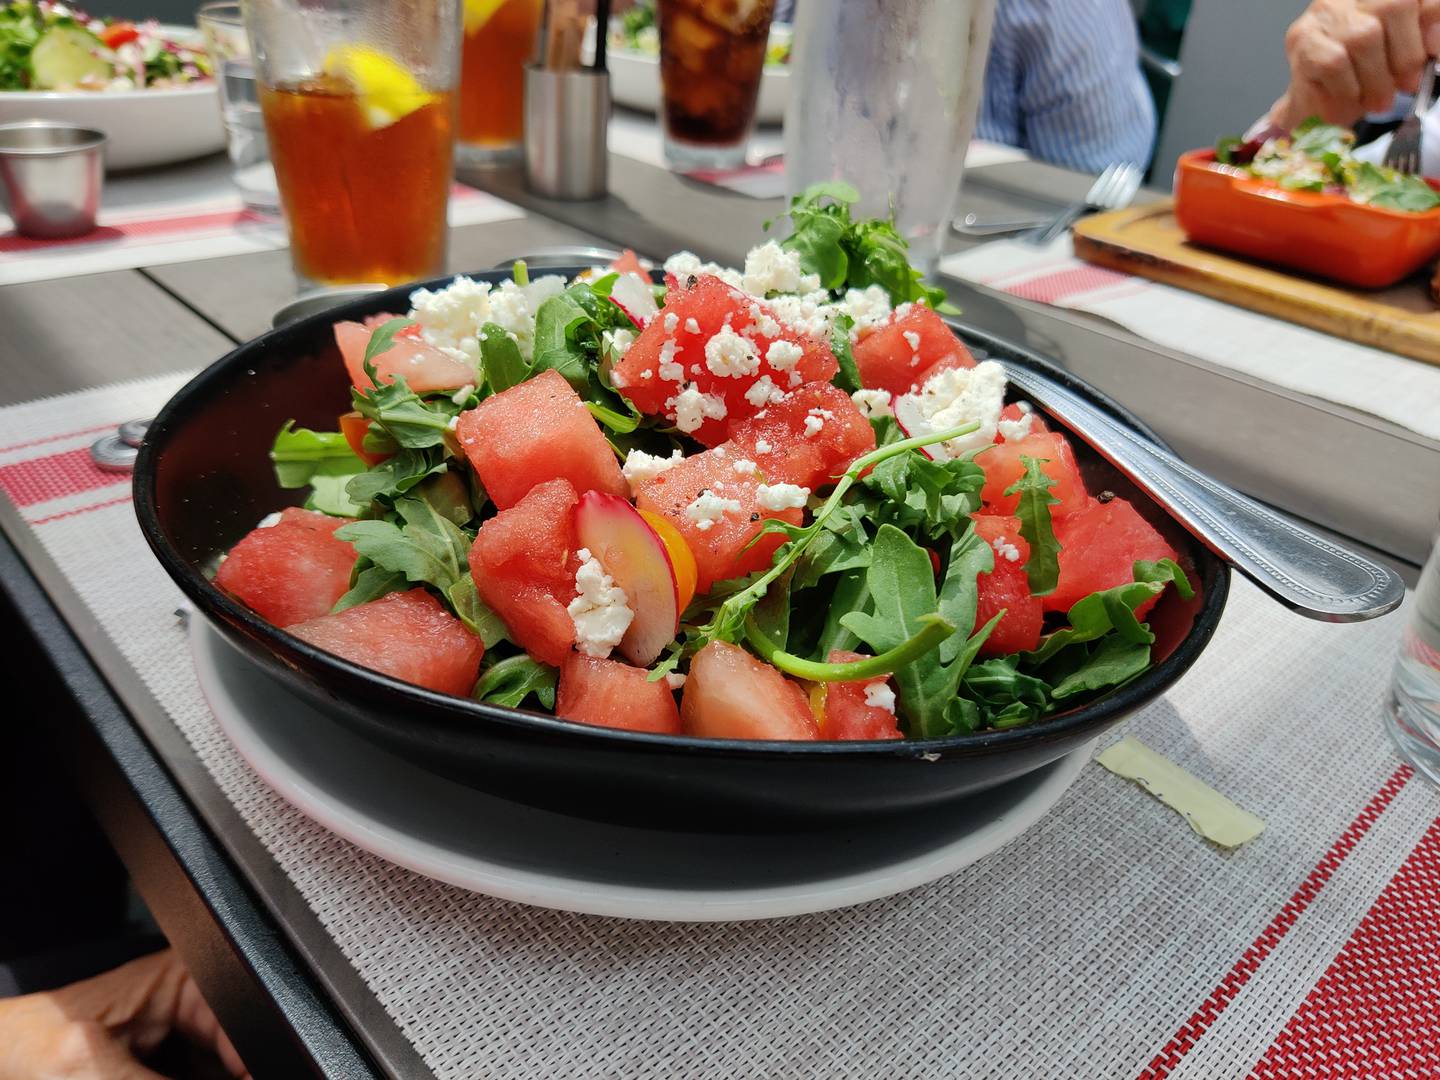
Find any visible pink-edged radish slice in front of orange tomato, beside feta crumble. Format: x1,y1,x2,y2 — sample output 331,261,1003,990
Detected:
575,491,681,667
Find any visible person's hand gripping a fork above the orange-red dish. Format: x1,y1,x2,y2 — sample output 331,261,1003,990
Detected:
1270,0,1440,128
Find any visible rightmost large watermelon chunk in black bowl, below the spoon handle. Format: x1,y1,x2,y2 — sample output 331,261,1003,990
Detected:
1041,498,1179,619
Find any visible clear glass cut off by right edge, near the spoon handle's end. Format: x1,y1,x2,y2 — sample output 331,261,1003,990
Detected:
1385,541,1440,785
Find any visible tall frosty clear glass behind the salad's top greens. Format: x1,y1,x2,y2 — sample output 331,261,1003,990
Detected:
785,0,995,272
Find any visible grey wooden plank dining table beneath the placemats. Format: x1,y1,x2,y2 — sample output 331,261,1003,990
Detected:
0,148,1440,1079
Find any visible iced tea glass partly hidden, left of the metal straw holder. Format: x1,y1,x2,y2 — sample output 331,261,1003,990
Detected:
455,0,544,164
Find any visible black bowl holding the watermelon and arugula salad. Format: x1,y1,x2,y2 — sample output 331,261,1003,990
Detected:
135,272,1230,829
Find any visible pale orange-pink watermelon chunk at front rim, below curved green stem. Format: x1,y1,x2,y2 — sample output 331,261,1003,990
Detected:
680,641,819,740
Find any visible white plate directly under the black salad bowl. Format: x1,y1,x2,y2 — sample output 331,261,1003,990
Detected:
190,615,1094,922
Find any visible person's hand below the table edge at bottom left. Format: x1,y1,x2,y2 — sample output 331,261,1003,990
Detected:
0,949,249,1080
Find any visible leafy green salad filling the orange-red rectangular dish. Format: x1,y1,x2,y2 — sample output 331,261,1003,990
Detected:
1215,117,1440,213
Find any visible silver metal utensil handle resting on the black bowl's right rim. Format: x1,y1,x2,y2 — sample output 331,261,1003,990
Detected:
1005,364,1405,622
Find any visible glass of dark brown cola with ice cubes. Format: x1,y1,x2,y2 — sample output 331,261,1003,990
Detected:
655,0,775,170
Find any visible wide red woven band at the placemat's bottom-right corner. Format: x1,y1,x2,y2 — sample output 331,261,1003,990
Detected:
1251,818,1440,1080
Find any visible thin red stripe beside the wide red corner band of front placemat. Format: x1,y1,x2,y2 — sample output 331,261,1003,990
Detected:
1139,765,1416,1080
